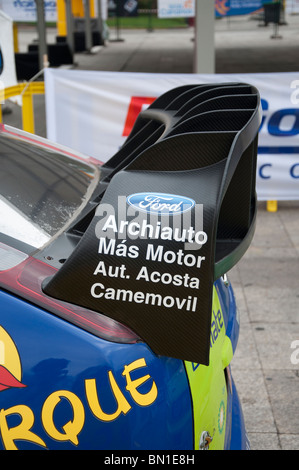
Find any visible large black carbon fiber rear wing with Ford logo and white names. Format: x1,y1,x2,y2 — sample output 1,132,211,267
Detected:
44,83,261,365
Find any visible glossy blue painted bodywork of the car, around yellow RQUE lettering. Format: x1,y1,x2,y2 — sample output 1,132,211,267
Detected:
0,280,249,451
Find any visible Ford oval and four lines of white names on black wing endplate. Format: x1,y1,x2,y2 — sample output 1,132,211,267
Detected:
90,196,208,318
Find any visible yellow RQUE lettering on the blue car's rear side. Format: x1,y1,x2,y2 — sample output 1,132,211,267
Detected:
0,358,158,450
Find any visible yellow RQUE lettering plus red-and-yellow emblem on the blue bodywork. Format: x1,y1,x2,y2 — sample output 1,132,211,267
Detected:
0,327,158,450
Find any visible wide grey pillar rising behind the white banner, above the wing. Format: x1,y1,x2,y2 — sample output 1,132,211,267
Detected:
194,0,215,73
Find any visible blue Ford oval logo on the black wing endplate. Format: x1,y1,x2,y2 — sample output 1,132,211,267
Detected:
127,193,195,215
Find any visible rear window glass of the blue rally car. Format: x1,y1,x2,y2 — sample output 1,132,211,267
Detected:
0,132,98,248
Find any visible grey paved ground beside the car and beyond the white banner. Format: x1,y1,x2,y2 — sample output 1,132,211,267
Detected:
5,12,299,450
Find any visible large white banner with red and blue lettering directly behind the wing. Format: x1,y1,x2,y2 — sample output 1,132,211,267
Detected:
45,69,299,200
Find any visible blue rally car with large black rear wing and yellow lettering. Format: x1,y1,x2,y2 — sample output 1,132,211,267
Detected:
0,83,260,455
